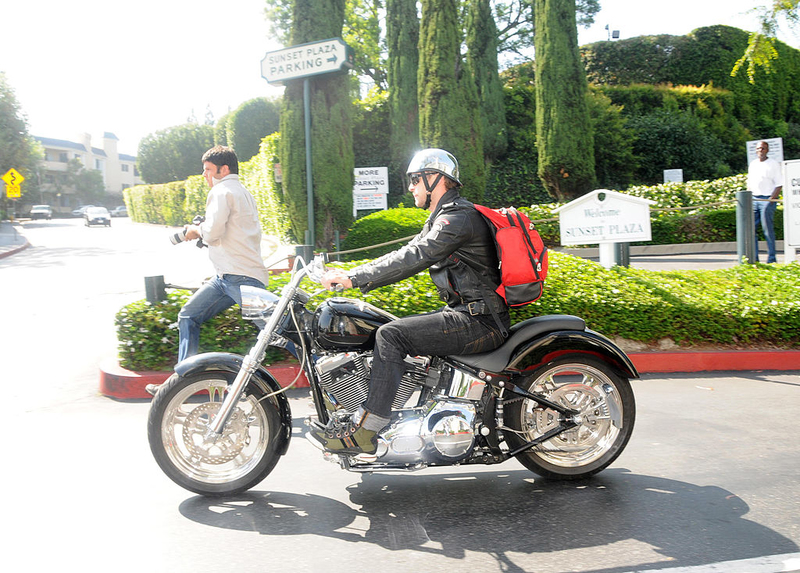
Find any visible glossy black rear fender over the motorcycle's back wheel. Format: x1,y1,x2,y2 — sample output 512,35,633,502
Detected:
508,330,639,378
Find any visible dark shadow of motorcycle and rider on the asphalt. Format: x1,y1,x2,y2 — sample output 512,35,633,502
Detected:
180,469,798,573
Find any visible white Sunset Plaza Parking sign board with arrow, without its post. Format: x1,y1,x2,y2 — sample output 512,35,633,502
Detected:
261,38,355,85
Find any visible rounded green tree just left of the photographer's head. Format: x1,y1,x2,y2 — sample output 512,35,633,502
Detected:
137,123,214,184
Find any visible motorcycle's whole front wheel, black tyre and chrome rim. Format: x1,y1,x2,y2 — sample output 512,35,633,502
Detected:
147,372,281,496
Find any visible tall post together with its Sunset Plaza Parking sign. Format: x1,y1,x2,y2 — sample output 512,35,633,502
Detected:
261,38,355,249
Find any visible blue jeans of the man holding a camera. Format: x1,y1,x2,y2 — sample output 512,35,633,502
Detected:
178,275,264,362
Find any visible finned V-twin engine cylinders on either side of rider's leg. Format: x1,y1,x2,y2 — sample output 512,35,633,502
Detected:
314,352,437,412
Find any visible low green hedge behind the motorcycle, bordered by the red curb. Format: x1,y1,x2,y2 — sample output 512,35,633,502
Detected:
116,252,800,370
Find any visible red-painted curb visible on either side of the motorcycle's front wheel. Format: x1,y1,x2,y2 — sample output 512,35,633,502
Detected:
100,359,308,400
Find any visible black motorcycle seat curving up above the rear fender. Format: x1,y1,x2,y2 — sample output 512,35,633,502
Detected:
450,314,586,372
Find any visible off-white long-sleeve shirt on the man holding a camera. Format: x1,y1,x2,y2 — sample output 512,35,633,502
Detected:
200,174,269,285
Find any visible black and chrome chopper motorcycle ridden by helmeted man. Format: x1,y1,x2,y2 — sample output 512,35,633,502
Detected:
148,256,638,496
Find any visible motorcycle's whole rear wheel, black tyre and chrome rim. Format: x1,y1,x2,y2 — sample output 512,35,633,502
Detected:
505,355,636,479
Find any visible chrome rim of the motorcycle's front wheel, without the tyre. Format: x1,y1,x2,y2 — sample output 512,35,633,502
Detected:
161,378,271,484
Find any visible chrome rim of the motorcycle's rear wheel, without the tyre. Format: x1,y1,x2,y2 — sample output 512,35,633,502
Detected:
521,364,623,468
